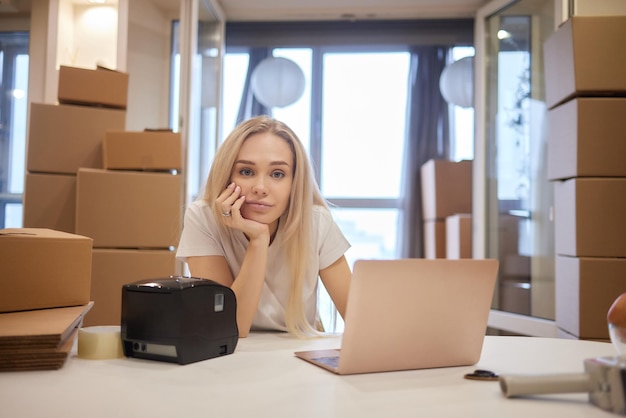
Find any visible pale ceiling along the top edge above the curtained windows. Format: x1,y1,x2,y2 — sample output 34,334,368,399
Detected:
0,0,488,21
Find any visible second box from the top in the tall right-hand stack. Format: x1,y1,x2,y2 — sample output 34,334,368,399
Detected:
548,97,626,180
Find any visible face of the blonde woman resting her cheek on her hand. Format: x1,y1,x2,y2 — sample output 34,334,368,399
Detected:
231,133,294,233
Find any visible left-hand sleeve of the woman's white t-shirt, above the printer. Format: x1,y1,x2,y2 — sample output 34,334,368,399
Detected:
176,200,224,261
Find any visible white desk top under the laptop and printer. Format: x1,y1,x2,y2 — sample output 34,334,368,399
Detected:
0,334,616,418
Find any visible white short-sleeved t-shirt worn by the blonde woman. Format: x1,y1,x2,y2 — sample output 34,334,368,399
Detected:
176,200,350,331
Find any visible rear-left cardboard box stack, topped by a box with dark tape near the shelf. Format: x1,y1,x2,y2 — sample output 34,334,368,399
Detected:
23,66,128,233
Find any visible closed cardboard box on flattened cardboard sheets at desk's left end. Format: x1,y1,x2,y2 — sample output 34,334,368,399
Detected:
0,228,93,371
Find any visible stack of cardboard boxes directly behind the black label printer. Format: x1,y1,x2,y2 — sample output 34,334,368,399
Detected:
76,131,183,325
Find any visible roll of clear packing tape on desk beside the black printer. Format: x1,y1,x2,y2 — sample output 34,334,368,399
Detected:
78,326,124,360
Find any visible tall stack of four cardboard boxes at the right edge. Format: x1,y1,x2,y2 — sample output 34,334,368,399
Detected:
544,16,626,339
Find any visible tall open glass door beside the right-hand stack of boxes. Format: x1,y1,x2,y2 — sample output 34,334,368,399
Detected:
475,0,558,335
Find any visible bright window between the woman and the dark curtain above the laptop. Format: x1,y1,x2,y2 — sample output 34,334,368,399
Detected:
316,51,409,264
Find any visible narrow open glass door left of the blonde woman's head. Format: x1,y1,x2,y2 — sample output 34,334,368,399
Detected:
176,0,224,202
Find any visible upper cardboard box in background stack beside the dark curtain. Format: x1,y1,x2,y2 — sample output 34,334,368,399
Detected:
420,160,472,221
